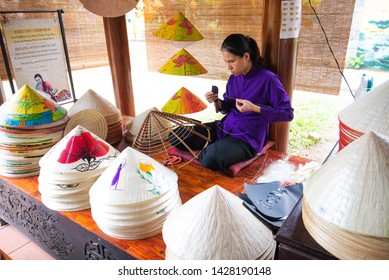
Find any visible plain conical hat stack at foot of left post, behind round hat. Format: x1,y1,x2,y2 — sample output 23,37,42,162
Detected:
69,89,123,144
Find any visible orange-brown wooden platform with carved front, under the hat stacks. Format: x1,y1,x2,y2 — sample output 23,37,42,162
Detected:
0,137,310,260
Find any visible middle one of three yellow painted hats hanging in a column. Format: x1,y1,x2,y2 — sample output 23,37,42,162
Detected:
159,49,208,76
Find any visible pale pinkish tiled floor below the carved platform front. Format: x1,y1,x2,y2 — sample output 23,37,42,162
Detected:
0,225,54,260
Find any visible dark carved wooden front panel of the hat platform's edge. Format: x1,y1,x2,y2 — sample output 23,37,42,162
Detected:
0,182,133,260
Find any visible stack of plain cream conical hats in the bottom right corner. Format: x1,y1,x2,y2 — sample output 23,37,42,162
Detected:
302,132,389,259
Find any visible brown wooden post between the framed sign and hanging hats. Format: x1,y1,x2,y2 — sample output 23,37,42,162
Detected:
103,15,135,117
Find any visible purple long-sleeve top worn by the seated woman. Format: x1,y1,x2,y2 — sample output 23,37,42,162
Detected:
217,65,294,152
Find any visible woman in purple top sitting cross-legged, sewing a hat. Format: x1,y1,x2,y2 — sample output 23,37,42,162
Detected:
168,34,294,170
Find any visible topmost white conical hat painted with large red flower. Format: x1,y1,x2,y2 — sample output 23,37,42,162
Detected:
39,126,119,177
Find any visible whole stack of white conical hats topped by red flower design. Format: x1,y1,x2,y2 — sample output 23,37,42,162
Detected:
38,126,119,211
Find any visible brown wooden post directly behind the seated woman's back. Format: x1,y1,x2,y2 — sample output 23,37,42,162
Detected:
262,0,298,153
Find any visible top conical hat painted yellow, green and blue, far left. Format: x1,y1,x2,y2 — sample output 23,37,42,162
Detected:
0,85,67,128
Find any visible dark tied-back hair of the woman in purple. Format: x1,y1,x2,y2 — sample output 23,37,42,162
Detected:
221,34,266,67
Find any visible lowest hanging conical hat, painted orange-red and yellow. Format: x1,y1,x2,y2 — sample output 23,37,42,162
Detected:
161,87,207,114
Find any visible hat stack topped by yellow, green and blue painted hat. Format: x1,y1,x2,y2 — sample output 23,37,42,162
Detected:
0,85,69,178
